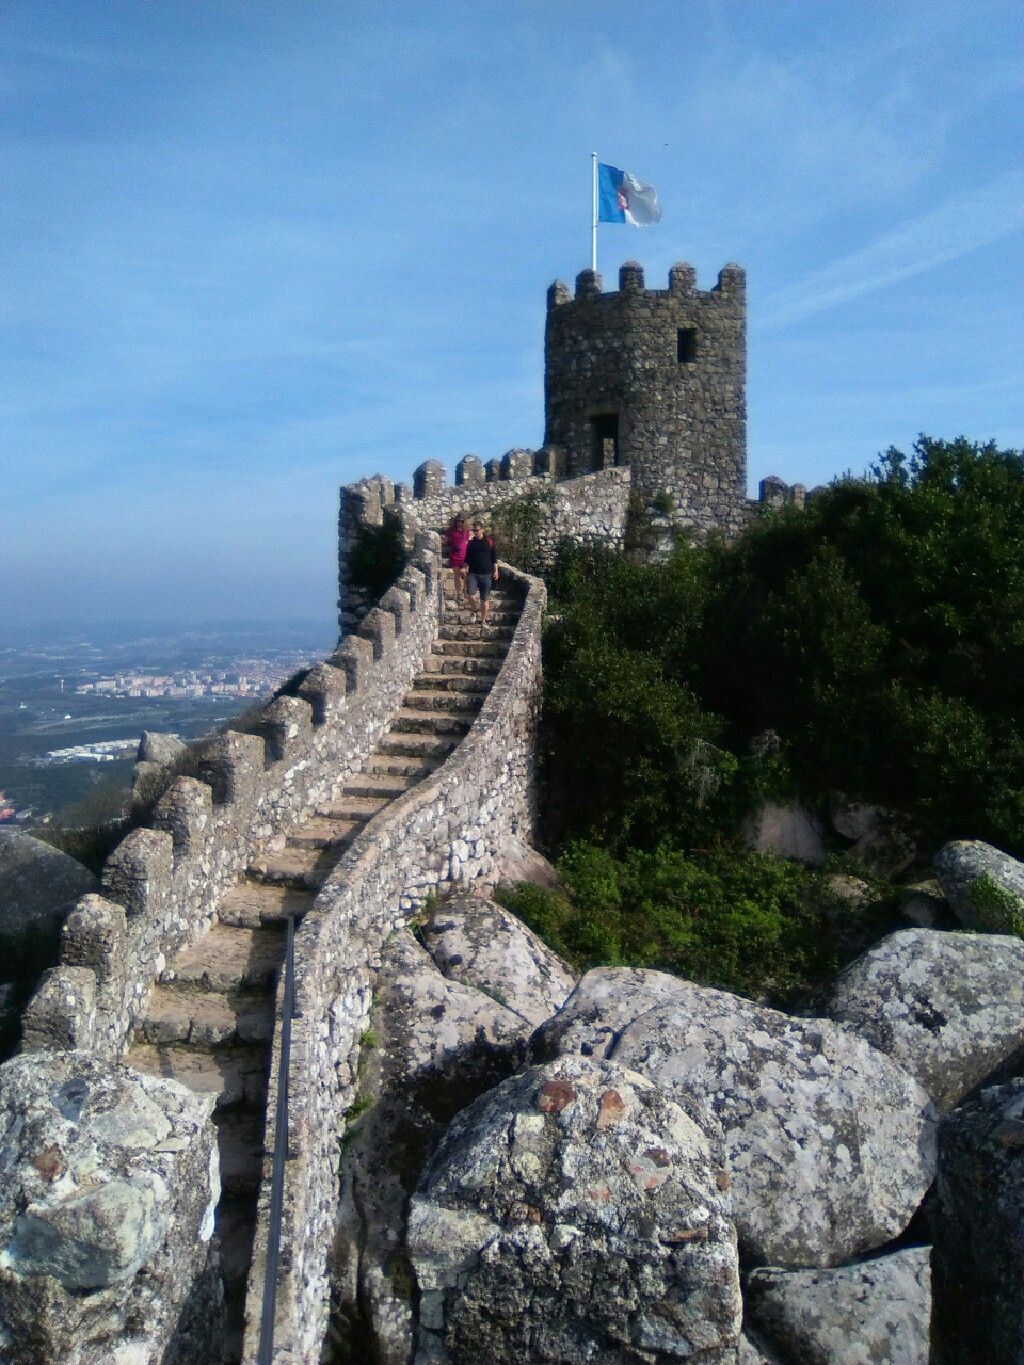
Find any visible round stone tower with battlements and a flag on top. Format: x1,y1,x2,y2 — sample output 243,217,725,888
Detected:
545,261,747,531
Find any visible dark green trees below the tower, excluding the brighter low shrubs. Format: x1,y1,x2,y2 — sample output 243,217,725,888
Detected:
545,437,1024,853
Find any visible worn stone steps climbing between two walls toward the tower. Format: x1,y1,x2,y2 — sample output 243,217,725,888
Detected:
126,573,519,1361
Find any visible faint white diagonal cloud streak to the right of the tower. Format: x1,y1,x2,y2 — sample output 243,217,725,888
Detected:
760,171,1024,328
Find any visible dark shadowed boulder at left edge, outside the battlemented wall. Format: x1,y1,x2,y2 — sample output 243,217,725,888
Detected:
0,830,100,980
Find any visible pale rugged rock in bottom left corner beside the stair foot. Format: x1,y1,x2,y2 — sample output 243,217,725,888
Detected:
0,1052,220,1365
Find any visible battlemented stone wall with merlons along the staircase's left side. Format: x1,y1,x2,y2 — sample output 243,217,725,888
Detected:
23,532,441,1059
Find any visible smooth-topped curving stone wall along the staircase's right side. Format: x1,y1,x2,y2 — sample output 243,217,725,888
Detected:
244,565,545,1365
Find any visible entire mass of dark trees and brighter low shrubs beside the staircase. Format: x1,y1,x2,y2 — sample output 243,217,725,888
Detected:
521,437,1024,1001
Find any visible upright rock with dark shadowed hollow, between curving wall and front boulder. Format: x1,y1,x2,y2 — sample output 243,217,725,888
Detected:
333,930,528,1365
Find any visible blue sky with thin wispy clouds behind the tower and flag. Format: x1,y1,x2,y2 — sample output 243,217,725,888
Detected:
0,0,1024,627
